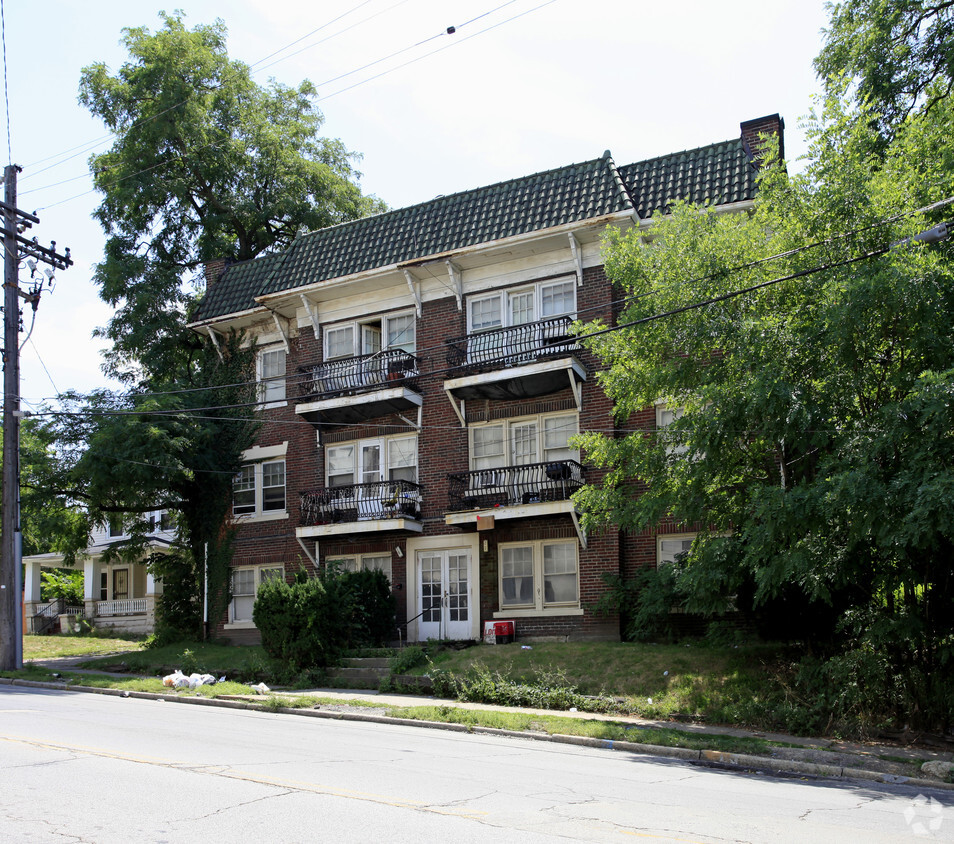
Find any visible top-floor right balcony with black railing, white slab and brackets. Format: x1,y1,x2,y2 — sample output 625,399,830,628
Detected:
444,316,586,421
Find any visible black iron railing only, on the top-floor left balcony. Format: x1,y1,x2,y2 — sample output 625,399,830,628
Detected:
298,349,418,399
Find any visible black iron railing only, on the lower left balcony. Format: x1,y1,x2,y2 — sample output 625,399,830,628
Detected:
300,481,423,525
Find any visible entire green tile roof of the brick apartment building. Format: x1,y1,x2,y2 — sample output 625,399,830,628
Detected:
196,140,755,321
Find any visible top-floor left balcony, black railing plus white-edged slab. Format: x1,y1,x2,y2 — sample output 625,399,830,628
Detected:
295,349,422,427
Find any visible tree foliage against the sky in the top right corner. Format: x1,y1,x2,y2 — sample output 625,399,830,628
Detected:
815,0,954,127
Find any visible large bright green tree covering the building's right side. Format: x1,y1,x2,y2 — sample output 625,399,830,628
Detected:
579,90,954,725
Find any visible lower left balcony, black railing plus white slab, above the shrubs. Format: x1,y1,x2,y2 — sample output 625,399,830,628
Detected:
298,481,423,538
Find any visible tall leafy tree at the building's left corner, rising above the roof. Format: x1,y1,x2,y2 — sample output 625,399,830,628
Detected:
50,13,382,635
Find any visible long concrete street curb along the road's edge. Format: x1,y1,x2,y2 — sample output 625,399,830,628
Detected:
0,677,954,791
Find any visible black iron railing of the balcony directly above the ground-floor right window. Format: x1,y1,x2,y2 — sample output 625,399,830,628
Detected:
447,460,584,510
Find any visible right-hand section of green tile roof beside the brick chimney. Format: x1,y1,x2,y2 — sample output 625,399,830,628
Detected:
619,138,755,218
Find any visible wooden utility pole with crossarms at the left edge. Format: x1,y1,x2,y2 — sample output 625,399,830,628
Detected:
0,164,73,671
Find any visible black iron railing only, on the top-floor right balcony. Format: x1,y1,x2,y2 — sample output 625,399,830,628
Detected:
447,316,580,371
